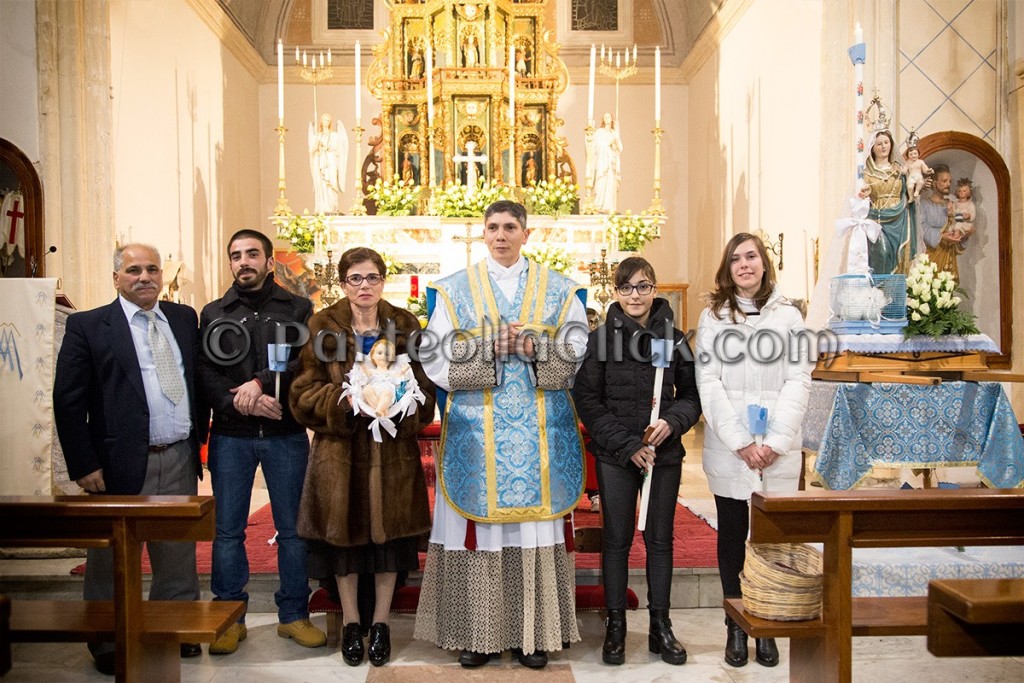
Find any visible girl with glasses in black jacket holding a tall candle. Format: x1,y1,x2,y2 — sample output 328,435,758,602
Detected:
572,256,700,665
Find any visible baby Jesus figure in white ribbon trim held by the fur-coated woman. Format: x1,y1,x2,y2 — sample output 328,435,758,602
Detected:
341,339,426,441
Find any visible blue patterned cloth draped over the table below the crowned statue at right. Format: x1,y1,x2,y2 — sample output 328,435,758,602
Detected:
803,381,1024,489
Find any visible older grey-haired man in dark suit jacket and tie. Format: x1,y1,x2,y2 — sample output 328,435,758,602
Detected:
53,244,208,675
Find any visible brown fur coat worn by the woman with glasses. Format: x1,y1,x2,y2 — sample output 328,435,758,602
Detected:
289,299,435,547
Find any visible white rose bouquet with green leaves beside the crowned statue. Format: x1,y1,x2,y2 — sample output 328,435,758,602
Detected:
903,254,978,337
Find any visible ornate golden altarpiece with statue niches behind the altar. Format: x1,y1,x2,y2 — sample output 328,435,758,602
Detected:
368,0,574,186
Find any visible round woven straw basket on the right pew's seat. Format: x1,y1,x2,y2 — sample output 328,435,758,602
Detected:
739,543,821,622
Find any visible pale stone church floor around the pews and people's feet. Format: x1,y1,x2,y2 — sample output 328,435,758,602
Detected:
0,428,1024,683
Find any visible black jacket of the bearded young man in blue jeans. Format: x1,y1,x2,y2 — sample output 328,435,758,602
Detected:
197,274,313,437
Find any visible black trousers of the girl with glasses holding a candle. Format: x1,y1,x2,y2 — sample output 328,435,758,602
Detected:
597,460,683,609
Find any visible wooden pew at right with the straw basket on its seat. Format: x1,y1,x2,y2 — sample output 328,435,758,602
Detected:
725,488,1024,683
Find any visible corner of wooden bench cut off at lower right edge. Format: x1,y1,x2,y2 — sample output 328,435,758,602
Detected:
928,579,1024,657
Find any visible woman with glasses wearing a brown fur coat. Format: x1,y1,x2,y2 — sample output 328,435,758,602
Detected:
290,247,435,667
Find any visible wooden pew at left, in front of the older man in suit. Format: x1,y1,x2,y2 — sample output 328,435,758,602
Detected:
0,496,245,683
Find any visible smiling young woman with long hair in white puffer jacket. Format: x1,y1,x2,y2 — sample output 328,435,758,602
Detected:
696,232,814,667
